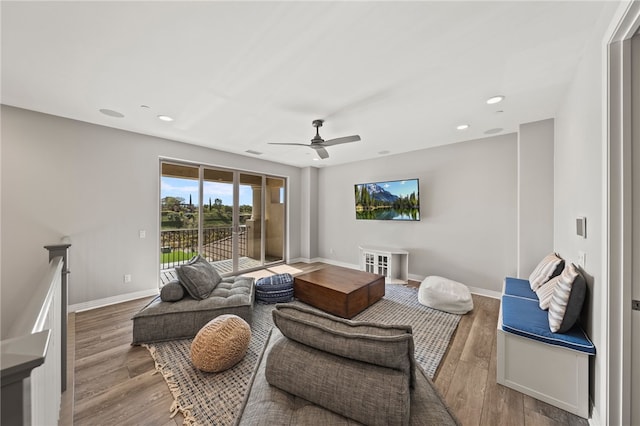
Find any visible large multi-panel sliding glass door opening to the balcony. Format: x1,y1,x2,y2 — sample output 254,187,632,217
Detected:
160,161,286,281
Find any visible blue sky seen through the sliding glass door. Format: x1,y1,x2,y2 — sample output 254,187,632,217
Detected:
160,176,253,206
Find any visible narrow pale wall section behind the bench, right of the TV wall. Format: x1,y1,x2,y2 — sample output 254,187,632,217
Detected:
518,119,554,279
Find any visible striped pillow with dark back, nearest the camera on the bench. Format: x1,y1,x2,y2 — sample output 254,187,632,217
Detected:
549,263,587,333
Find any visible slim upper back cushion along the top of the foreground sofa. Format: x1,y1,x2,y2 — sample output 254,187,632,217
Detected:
273,304,415,383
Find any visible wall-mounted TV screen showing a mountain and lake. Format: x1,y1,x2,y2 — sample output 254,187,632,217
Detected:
355,179,420,221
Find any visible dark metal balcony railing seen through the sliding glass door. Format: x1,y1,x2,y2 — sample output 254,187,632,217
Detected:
160,225,247,269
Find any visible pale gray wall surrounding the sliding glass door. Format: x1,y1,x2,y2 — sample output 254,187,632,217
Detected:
1,106,301,334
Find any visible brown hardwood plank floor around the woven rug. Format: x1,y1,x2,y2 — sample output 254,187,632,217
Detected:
60,263,588,426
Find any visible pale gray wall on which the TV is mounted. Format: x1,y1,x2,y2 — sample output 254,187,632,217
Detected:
318,134,517,292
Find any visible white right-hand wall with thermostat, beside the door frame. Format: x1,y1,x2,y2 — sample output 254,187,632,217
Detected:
553,2,620,425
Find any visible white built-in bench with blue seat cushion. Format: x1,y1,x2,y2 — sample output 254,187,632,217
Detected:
497,278,596,418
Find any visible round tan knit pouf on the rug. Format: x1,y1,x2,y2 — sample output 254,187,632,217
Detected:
191,314,251,373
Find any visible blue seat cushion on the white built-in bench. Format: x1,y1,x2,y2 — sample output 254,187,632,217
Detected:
501,294,596,355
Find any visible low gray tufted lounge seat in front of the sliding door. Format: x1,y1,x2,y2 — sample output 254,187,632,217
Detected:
132,276,254,345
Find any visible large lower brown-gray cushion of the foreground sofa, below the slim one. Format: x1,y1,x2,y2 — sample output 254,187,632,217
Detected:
265,337,411,426
